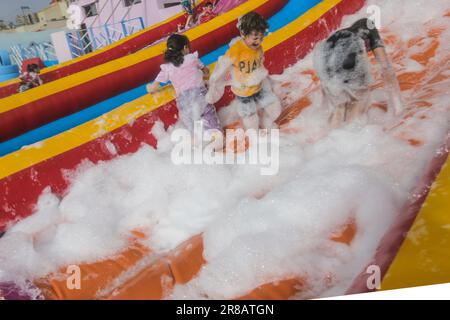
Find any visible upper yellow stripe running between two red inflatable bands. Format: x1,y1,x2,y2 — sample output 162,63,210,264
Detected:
0,0,269,113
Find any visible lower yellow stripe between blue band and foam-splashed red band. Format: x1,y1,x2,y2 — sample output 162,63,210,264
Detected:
0,0,342,179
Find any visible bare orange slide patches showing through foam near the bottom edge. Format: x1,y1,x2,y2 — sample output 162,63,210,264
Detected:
35,220,357,300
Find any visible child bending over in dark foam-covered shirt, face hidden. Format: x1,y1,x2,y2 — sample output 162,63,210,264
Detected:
314,19,403,128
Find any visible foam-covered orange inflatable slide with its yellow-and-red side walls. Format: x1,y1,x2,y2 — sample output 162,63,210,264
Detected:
0,0,450,299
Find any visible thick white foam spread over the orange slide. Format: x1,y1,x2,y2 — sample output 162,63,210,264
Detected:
0,0,450,298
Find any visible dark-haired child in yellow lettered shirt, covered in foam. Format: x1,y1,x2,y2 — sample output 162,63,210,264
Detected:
206,12,281,130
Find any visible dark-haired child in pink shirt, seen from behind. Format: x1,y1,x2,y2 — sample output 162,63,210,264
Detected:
147,34,220,132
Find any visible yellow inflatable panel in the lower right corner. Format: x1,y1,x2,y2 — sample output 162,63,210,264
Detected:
381,158,450,290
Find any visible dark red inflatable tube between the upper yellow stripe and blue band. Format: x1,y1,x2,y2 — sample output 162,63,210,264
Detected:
0,0,288,142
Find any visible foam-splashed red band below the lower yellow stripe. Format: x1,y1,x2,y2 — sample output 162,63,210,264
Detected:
0,0,364,232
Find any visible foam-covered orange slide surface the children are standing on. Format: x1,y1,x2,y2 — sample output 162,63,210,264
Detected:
0,1,450,299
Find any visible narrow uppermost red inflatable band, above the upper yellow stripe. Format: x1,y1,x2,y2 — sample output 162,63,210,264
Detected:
0,2,209,99
